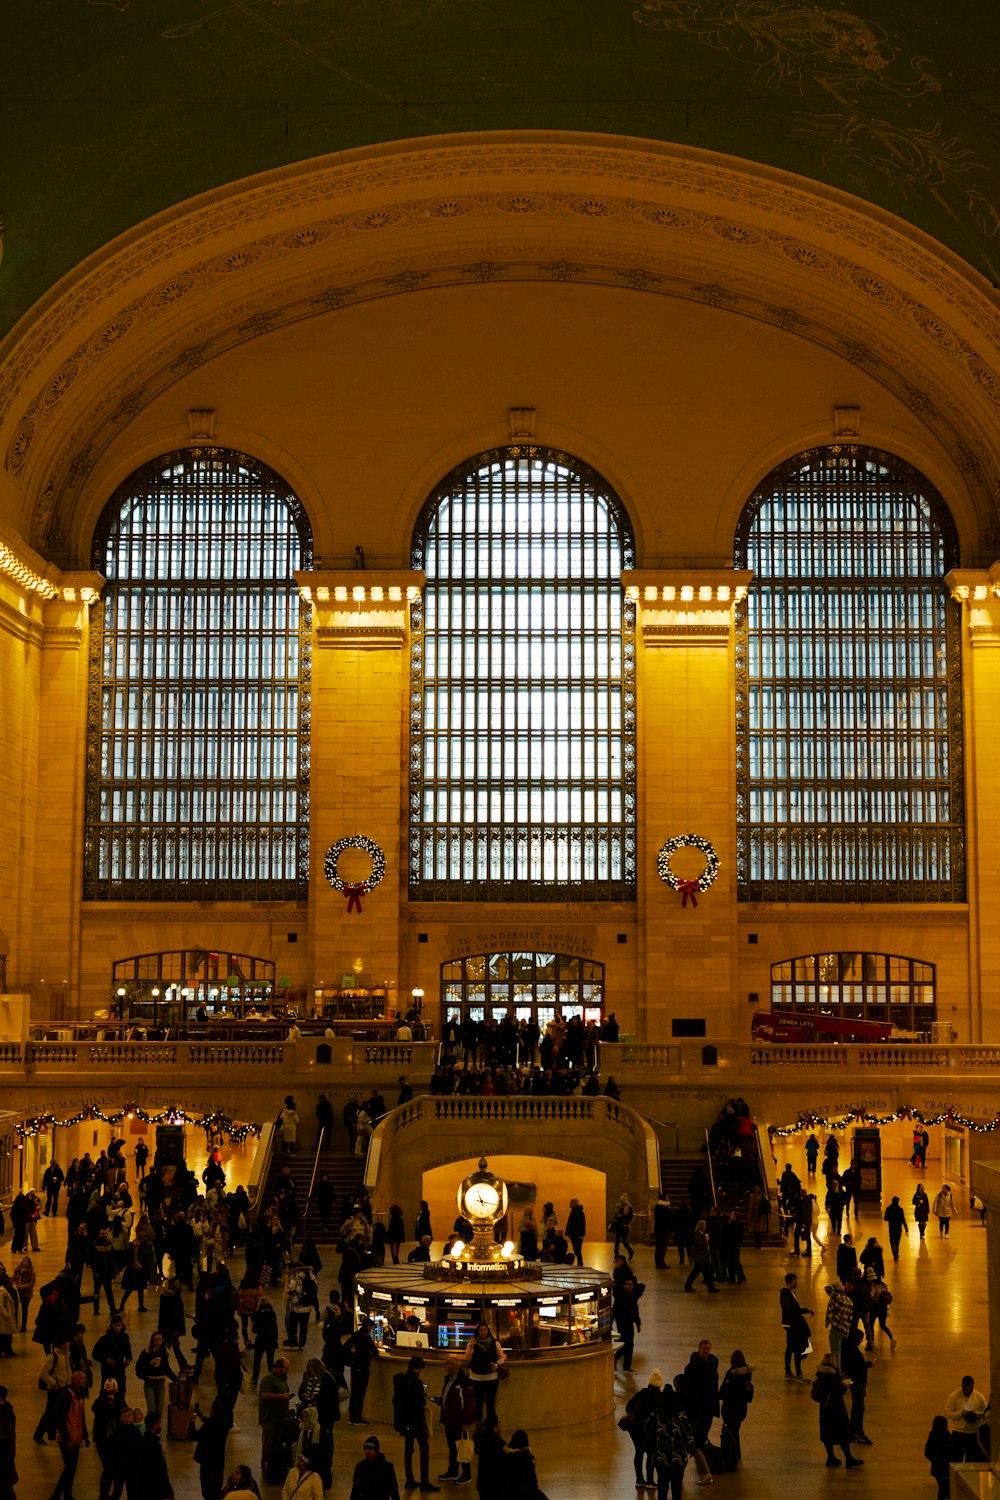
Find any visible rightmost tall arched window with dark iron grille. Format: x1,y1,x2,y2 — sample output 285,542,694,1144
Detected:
736,446,966,902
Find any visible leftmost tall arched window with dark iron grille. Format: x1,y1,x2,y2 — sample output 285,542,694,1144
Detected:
84,449,312,902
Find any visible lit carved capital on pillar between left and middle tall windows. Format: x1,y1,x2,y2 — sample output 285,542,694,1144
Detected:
295,569,424,651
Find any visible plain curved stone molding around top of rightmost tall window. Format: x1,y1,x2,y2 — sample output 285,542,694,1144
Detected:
715,423,983,564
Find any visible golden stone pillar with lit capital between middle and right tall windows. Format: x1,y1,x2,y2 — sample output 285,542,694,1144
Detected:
622,567,753,1043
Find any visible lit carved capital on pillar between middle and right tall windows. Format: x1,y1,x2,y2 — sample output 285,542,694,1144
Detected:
622,567,753,647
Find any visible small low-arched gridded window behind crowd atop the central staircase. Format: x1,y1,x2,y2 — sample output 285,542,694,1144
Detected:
441,953,604,1032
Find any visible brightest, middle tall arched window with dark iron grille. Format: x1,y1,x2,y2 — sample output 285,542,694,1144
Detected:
409,446,636,902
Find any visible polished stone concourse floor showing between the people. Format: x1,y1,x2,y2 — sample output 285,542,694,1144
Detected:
0,1142,988,1500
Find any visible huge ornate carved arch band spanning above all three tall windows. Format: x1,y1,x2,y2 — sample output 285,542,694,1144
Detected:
0,132,1000,555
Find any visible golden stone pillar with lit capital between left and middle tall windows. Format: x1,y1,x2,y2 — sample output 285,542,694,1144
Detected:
295,569,423,986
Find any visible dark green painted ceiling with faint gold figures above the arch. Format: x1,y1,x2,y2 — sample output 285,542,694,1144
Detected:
0,0,1000,337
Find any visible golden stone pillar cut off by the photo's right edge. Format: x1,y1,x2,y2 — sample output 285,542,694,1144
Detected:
946,563,1000,1050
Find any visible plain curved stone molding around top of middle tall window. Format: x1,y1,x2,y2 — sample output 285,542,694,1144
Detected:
390,417,645,567
